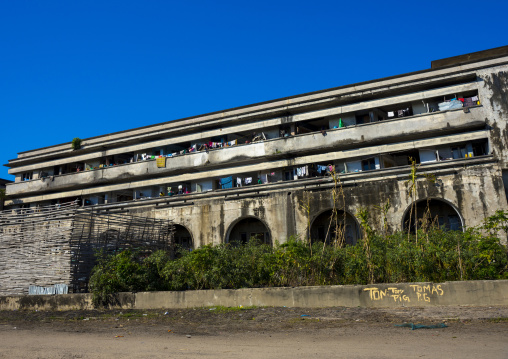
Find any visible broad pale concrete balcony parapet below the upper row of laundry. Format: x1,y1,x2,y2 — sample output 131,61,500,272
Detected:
7,107,485,195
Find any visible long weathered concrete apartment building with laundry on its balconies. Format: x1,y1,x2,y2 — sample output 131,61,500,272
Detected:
5,46,508,247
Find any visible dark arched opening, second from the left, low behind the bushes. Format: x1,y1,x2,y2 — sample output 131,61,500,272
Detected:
226,217,272,244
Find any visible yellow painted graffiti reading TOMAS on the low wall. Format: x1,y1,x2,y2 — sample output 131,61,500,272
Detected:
363,284,444,303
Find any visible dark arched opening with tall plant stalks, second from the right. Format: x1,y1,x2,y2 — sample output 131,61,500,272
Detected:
310,209,360,245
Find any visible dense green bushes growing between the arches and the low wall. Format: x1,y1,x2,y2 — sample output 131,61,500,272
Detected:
90,210,508,305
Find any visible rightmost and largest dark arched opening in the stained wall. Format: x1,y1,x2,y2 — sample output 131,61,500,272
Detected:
403,198,463,232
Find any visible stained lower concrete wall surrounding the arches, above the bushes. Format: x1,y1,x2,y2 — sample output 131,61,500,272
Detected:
121,160,506,246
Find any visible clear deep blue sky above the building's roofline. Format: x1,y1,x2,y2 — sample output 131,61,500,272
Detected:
0,0,508,180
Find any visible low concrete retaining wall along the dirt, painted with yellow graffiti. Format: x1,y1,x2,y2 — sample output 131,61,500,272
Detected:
0,280,508,310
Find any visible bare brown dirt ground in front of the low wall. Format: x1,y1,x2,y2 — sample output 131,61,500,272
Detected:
0,306,508,359
